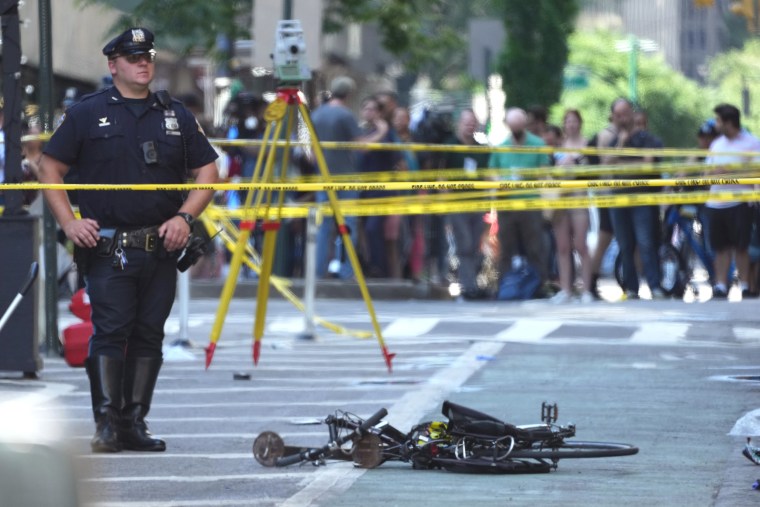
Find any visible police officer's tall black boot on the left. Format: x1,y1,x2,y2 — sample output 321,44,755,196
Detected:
86,356,124,452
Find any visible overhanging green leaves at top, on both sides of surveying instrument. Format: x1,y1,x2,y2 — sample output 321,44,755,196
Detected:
78,0,493,82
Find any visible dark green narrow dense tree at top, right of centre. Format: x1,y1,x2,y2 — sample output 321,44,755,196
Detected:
495,0,578,107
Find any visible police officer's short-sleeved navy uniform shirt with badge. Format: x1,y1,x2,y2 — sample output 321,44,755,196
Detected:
44,87,217,227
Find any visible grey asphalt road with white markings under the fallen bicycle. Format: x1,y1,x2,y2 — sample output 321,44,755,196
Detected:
0,299,760,507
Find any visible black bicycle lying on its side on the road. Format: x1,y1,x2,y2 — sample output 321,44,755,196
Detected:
253,401,639,474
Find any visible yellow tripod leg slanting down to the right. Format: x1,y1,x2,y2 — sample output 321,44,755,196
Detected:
299,104,396,372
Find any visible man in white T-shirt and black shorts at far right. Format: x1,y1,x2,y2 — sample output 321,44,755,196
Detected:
705,104,760,299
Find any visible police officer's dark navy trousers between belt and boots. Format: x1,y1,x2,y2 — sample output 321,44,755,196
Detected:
85,249,177,359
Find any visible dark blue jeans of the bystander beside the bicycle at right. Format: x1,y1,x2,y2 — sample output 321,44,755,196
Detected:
610,206,660,292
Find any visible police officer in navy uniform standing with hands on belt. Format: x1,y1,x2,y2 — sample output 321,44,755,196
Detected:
39,28,217,452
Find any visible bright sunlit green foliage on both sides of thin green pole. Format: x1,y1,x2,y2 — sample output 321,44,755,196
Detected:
552,32,715,147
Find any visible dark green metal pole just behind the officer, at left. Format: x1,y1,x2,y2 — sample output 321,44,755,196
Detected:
39,0,60,356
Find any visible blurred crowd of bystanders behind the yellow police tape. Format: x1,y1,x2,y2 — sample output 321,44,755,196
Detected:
191,76,760,303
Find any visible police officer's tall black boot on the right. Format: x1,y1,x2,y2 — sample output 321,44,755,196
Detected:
121,357,166,452
